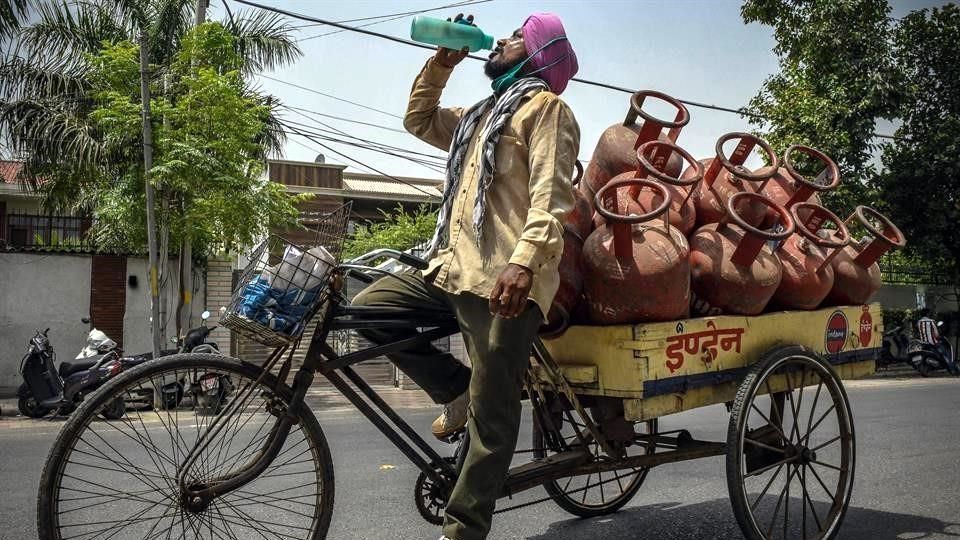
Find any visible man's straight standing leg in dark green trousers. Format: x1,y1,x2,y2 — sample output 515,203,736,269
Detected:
443,293,540,540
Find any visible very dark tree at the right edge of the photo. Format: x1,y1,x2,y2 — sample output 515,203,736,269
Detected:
877,4,960,283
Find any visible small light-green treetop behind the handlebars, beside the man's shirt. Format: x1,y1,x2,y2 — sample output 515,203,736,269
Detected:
343,204,437,259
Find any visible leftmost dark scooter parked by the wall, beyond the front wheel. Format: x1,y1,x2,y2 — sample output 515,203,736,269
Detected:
17,319,126,420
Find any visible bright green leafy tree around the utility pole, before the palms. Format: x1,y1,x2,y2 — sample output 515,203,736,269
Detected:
81,23,306,256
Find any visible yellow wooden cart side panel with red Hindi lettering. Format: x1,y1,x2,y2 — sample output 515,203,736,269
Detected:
544,304,883,400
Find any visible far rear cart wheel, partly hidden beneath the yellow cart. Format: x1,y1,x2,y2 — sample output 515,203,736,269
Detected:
533,408,657,518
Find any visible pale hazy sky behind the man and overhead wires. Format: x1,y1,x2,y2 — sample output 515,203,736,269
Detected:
211,0,942,178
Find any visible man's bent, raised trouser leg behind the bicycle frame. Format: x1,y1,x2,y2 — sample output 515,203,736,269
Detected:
353,273,470,404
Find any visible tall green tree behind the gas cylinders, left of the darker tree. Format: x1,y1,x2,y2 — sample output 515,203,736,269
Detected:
741,0,903,216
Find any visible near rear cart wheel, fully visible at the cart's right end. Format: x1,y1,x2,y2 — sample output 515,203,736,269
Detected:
727,346,856,540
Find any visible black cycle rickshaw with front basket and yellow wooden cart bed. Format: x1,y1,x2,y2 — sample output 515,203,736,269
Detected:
38,204,883,540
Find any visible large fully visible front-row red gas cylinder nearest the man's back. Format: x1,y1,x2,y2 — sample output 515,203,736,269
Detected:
583,179,690,324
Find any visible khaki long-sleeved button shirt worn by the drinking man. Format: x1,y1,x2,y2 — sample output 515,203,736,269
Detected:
403,58,580,318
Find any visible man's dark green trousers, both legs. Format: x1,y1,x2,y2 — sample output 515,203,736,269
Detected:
353,274,540,540
